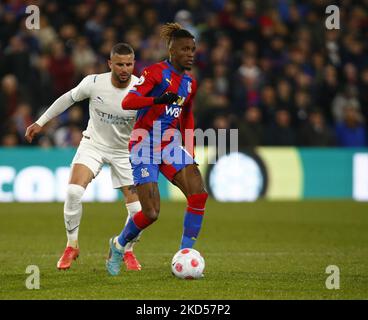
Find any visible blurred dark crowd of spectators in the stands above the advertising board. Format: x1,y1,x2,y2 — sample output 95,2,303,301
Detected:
0,0,368,147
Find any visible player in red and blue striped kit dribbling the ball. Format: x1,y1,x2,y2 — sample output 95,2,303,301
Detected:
106,23,208,275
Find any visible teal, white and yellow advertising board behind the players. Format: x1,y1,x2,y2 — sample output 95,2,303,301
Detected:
0,147,368,202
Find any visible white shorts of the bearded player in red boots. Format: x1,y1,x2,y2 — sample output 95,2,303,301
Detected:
71,137,134,188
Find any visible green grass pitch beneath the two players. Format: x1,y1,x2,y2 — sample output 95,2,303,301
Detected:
0,200,368,300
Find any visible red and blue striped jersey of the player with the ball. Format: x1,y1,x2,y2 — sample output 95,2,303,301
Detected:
122,60,197,154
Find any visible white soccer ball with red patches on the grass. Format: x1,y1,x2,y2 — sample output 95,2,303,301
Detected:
171,248,205,279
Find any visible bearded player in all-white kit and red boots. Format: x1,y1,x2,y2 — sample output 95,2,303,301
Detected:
25,43,141,270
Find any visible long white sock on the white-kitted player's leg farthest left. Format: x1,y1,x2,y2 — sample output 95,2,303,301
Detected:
64,184,85,248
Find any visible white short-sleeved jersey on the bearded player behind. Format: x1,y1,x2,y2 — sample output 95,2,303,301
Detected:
71,72,138,153
